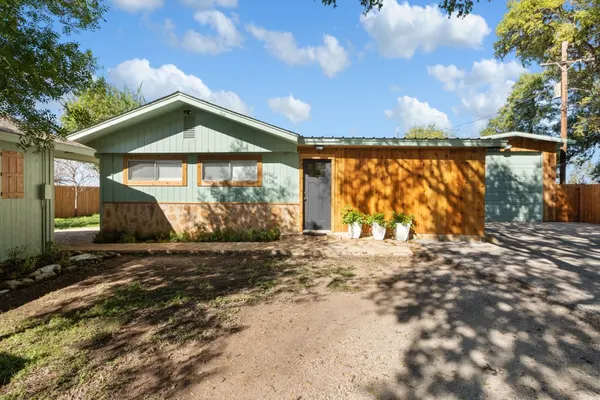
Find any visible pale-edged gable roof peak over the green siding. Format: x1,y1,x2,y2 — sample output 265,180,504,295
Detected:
68,91,299,143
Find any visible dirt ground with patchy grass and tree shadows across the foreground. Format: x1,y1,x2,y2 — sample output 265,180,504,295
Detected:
0,246,600,400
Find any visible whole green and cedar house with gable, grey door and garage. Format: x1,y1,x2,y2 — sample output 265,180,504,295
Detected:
69,92,560,236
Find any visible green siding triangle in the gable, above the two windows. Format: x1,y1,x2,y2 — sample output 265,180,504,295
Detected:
87,107,296,153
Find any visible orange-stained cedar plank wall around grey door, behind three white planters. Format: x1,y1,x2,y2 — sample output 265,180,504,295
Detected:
299,146,486,236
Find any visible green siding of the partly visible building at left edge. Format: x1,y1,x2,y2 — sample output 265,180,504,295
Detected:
0,141,54,260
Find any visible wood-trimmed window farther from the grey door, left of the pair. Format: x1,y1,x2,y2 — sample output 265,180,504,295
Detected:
123,155,187,186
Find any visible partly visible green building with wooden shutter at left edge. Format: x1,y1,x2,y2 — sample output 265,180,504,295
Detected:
0,119,96,260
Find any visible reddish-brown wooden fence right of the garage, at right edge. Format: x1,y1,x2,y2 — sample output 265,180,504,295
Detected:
556,185,600,224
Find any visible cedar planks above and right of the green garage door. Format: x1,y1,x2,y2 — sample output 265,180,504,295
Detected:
502,138,558,222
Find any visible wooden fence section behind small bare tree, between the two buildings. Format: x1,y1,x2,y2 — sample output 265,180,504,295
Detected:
54,186,100,218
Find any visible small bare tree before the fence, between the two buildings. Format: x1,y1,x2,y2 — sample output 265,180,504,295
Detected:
54,159,98,216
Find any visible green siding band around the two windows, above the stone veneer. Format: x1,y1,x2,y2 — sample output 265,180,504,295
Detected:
99,153,299,203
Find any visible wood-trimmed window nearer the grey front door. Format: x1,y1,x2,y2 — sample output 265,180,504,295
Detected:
198,155,262,186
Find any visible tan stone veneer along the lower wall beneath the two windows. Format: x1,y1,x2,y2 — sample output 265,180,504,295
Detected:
101,203,300,234
